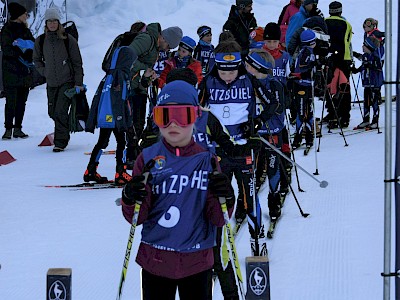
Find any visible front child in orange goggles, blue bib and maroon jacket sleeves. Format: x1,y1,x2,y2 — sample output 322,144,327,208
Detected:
122,80,234,300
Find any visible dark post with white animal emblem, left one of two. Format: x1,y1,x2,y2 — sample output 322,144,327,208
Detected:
46,268,72,300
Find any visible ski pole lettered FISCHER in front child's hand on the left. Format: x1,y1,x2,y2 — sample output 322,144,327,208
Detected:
117,159,155,300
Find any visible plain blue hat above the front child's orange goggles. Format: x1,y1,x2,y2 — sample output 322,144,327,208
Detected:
157,80,200,106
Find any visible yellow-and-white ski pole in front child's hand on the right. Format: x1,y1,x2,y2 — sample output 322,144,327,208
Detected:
211,158,245,300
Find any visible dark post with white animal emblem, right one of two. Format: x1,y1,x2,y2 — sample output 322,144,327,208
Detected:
246,256,270,300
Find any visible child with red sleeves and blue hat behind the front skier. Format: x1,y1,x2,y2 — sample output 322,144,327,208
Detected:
158,36,203,89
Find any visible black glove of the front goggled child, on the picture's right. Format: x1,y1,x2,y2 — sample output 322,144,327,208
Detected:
208,172,235,208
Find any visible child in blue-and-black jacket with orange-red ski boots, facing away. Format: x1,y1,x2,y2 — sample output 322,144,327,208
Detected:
83,47,137,185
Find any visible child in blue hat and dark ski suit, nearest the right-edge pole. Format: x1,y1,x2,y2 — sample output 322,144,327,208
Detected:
352,37,383,129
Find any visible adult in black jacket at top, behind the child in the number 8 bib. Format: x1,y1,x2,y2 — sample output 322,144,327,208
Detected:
223,0,257,58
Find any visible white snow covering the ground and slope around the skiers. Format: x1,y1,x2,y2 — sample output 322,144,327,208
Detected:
0,0,397,300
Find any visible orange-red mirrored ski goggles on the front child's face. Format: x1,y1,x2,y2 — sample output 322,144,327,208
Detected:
153,105,201,128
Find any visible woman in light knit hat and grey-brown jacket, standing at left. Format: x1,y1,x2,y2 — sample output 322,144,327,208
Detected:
33,6,84,152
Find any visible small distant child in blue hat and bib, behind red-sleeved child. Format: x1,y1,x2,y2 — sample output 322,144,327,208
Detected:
193,25,214,75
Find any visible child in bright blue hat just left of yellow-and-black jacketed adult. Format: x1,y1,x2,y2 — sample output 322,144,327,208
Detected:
292,29,316,149
